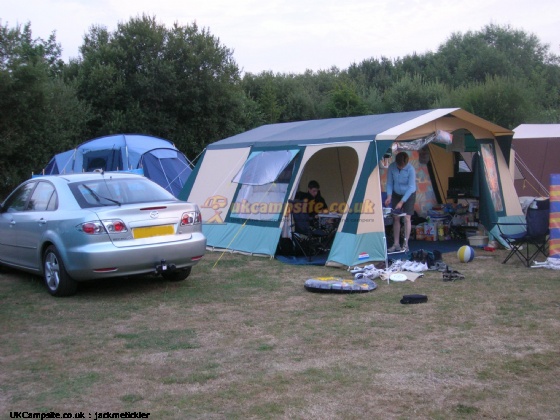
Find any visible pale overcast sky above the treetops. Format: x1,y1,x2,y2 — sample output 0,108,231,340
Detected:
0,0,560,74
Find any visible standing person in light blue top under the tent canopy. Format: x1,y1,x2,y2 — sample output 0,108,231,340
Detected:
385,152,416,252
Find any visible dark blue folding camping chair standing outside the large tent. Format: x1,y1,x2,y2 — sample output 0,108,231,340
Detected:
496,199,550,267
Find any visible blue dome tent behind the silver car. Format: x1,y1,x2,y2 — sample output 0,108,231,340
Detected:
43,134,192,196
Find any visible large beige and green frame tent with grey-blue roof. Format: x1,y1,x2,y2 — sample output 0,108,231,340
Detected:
179,108,523,267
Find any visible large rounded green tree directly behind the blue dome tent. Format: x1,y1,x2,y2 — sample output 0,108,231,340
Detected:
67,15,252,157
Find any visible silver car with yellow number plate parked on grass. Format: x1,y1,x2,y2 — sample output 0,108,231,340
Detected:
0,172,206,296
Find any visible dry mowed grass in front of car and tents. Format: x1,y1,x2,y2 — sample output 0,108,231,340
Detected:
0,251,560,419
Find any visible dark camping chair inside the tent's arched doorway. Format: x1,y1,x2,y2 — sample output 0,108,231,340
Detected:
289,200,331,260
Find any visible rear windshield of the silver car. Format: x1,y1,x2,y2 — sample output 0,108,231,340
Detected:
69,178,176,208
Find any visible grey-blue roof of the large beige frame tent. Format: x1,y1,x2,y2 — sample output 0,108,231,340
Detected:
208,108,513,149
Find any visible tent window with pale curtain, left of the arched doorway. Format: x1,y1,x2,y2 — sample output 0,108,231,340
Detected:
230,150,297,221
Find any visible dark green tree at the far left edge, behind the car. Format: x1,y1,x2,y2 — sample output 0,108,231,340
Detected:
0,23,89,196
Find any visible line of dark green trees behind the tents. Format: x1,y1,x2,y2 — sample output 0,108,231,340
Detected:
0,15,560,197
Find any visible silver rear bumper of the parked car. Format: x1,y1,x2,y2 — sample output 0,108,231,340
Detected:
63,233,206,281
